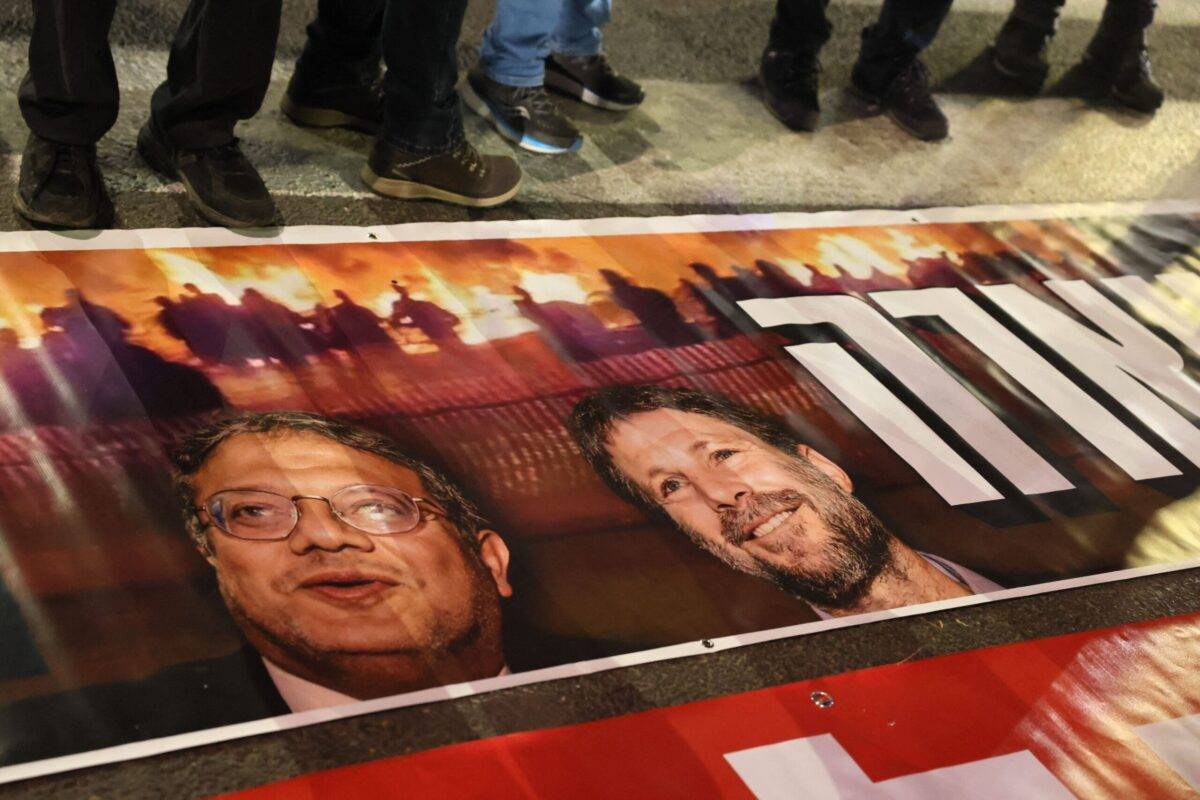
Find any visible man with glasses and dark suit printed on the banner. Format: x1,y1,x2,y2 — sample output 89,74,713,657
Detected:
0,411,512,764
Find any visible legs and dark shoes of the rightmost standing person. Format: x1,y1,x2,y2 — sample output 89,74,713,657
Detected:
992,0,1164,114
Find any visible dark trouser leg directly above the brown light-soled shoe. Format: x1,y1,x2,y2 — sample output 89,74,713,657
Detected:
380,0,467,154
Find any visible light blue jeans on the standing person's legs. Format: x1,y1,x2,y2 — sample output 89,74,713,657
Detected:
479,0,612,86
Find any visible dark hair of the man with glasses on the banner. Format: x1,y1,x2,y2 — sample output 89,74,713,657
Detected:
172,411,487,554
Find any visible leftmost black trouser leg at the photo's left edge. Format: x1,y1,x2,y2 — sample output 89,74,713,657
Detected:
17,0,119,145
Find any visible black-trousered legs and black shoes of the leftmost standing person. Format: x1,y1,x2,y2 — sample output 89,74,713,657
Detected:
13,0,281,228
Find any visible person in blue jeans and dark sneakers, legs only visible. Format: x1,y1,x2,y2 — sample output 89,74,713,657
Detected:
461,0,644,154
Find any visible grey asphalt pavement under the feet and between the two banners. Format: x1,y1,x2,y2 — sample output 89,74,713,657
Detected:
0,0,1200,799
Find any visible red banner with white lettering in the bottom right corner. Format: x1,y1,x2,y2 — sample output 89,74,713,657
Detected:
218,614,1200,800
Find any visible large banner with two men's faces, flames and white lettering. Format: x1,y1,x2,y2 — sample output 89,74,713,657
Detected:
0,203,1200,781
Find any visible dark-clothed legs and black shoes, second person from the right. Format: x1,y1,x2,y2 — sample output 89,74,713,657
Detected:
758,0,952,140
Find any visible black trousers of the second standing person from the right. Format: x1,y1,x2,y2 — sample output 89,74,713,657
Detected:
768,0,952,92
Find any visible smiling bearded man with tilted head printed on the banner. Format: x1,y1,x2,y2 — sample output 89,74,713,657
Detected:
568,385,1000,619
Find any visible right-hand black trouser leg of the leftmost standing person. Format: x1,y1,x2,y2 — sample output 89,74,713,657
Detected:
148,0,282,149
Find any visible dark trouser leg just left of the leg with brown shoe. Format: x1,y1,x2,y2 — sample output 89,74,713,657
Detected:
296,0,385,86
